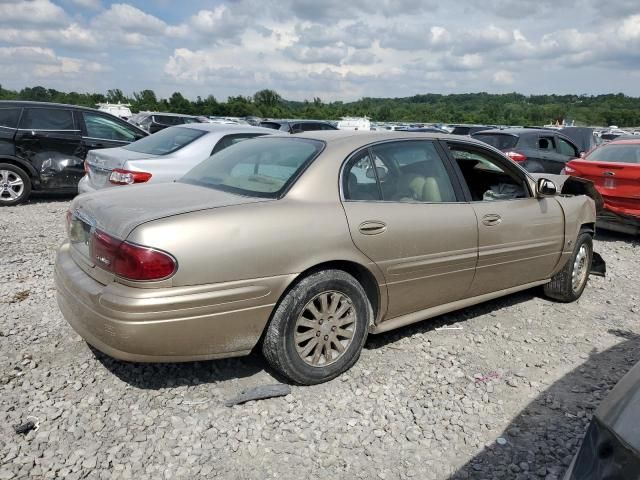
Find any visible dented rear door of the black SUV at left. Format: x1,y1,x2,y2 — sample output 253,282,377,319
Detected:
15,107,84,190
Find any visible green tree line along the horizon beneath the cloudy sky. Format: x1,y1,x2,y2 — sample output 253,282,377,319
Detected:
0,86,640,127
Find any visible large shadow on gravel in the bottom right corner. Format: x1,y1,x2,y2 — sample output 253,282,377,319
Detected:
450,330,640,480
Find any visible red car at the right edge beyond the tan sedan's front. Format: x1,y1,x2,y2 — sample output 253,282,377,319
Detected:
564,138,640,234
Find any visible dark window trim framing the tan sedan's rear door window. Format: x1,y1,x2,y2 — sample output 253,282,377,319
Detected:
338,138,467,205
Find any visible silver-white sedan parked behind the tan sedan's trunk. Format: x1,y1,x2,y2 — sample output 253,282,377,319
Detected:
78,123,275,193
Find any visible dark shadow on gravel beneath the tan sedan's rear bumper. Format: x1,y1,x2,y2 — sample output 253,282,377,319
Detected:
90,347,268,390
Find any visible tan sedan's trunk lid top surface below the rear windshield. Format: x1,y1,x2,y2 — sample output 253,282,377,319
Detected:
71,182,267,239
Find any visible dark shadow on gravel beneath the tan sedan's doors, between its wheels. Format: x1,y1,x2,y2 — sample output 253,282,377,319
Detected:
365,288,540,350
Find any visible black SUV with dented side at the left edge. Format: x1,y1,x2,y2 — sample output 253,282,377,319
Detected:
0,101,147,206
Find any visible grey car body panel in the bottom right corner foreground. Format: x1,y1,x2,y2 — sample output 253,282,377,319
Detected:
595,363,640,453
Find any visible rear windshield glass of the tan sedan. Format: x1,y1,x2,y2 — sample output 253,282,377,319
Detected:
180,138,324,198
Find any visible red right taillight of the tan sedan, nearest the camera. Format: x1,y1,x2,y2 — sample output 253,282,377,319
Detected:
91,230,177,281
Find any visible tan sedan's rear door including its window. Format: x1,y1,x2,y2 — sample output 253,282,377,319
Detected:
342,140,478,319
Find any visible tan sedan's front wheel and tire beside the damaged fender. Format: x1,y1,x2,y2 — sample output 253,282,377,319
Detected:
544,232,593,303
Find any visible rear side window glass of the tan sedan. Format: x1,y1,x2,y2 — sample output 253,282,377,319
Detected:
343,140,457,203
